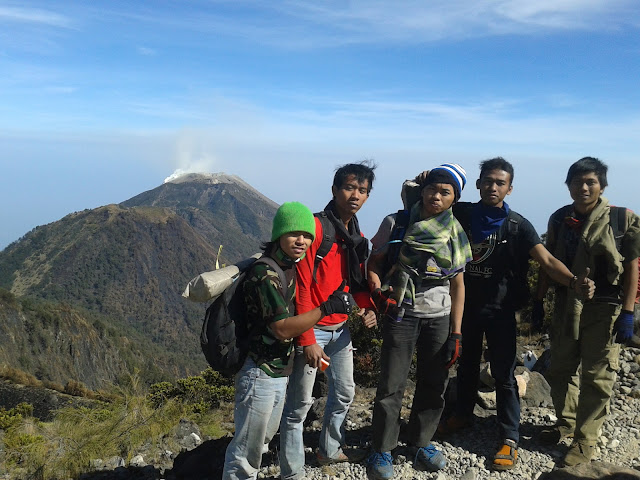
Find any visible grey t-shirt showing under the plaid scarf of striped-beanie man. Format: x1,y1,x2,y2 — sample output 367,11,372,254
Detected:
371,213,451,318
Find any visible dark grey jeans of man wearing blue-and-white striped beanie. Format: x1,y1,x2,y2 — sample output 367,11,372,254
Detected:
372,315,450,452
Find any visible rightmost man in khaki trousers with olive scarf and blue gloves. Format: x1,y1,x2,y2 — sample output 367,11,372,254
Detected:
538,157,640,466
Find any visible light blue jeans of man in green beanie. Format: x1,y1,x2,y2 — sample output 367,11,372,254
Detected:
222,358,288,480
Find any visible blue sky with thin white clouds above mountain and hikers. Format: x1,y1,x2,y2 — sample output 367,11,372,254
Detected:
0,0,640,248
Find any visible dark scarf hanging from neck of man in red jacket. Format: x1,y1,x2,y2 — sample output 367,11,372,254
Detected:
324,200,369,292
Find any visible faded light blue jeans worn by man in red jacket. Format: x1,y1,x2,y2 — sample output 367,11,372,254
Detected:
280,324,355,480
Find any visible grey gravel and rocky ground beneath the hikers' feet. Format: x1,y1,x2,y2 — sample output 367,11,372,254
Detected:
77,347,640,480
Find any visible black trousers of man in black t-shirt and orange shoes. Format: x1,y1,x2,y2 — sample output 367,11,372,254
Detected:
456,305,520,443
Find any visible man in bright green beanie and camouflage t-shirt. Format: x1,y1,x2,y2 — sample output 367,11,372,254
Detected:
222,202,355,480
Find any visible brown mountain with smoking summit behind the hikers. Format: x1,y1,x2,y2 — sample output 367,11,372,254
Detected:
0,174,277,381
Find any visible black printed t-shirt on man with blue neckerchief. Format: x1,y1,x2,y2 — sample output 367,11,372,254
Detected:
453,202,541,311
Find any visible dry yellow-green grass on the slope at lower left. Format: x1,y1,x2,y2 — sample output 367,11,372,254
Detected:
4,377,233,480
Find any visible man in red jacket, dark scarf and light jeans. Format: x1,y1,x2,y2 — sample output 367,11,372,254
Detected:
280,162,377,479
